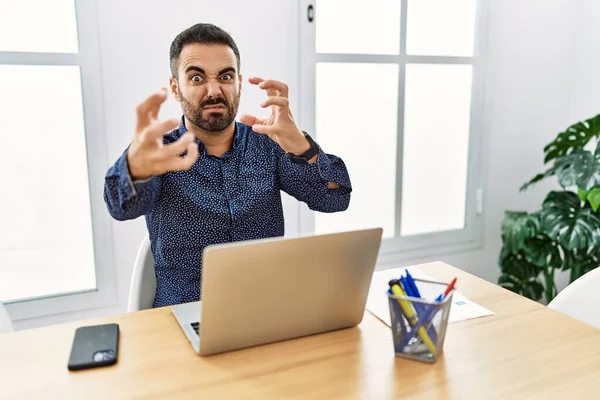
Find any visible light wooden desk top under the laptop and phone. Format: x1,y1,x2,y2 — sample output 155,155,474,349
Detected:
0,263,600,400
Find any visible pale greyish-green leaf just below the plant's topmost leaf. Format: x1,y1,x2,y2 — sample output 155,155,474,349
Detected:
554,149,600,191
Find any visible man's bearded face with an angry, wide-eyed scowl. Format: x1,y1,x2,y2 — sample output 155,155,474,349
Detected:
171,43,242,133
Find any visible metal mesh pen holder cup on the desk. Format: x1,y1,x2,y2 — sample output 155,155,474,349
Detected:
388,279,454,363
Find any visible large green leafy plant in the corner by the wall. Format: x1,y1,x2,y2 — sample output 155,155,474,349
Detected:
498,114,600,302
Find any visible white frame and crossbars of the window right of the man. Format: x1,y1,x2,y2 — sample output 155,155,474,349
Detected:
299,0,489,264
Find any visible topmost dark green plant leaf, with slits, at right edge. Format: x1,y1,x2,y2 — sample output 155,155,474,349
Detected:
544,114,600,164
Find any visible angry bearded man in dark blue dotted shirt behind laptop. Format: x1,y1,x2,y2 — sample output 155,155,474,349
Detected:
104,24,352,307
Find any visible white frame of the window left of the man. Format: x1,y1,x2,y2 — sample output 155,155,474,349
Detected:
0,0,117,321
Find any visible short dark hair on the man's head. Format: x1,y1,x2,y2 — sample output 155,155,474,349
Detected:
169,24,241,77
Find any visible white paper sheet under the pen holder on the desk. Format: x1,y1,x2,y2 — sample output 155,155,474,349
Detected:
366,267,494,326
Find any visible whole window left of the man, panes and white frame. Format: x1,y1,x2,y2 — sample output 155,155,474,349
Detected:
0,0,115,320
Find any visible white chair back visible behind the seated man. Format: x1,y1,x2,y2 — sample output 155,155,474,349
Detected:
127,236,156,312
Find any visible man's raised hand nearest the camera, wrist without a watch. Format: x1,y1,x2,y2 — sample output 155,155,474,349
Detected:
127,88,198,180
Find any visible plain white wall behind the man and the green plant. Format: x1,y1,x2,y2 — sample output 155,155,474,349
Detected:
17,0,600,328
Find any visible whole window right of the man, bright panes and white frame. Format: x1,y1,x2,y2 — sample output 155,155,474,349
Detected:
300,0,484,256
